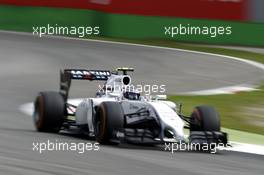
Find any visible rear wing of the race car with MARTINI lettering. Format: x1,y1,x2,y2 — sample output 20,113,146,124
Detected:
60,69,111,102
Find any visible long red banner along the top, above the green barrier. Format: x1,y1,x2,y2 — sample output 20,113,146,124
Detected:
0,0,250,21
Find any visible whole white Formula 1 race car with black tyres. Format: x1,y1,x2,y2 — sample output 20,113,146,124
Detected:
33,68,227,144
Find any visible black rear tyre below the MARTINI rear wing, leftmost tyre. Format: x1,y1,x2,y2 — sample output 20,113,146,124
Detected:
33,92,66,133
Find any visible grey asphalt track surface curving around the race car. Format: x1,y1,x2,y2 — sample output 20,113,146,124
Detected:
0,33,264,175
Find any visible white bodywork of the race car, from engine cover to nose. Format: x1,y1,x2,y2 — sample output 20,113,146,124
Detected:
58,71,185,141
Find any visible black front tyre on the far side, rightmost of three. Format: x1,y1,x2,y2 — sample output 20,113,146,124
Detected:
190,106,220,131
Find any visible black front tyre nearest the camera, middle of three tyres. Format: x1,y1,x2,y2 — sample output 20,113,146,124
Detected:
94,101,124,144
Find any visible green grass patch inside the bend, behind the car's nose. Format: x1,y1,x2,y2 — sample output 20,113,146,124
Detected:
169,86,264,134
